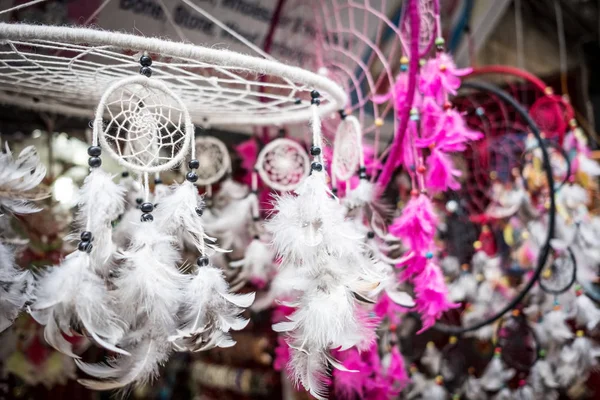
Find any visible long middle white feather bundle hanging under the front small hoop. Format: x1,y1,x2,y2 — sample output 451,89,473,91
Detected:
78,222,189,390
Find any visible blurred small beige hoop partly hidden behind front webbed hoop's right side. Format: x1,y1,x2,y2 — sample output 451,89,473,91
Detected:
195,136,231,186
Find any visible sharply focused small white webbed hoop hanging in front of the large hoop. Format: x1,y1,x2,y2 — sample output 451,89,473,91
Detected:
92,76,194,173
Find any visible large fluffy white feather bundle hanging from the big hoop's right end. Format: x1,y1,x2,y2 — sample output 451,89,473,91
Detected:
267,171,383,398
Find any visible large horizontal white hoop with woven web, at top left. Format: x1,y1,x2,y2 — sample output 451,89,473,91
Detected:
0,23,347,125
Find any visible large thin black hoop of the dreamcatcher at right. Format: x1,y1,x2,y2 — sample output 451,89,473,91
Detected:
433,82,556,335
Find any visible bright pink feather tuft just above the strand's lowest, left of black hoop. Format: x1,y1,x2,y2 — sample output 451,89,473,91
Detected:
389,194,438,250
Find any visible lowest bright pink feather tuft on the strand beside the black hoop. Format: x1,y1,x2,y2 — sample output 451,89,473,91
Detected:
413,261,458,333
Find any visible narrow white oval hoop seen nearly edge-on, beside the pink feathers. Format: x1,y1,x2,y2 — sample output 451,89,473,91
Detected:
331,115,364,181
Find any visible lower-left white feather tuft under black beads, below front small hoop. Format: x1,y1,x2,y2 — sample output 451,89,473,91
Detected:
30,252,126,355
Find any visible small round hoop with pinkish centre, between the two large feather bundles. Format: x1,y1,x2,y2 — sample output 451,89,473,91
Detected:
256,138,310,191
